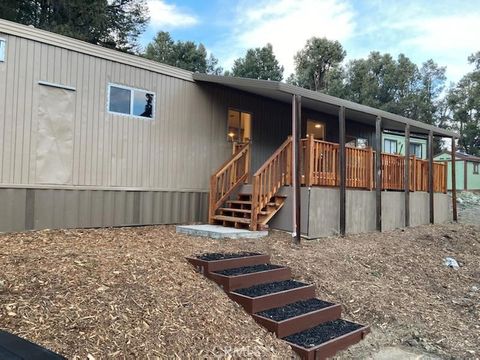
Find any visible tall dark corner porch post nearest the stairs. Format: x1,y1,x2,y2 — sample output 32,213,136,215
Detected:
292,95,302,244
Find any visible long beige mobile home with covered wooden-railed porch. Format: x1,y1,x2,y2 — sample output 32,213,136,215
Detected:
0,20,458,238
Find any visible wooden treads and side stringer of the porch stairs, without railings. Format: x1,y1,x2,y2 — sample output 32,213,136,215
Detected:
213,192,286,230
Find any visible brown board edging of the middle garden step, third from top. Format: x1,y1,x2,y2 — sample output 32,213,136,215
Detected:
228,285,315,314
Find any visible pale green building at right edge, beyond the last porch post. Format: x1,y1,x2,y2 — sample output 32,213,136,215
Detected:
435,151,480,191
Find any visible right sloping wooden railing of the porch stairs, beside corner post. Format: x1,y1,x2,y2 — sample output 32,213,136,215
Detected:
250,136,292,229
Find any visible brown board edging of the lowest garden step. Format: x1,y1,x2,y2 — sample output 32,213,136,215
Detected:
286,326,370,360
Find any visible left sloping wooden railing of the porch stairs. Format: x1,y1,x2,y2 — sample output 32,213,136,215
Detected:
208,144,250,223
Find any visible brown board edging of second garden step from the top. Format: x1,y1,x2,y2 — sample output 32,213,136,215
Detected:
210,268,292,292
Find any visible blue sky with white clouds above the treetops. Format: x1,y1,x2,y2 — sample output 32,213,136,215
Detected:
140,0,480,81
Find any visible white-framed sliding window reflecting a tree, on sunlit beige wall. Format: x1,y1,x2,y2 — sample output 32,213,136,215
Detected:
107,84,155,119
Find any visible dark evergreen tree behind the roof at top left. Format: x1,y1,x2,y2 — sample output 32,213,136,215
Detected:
0,0,149,51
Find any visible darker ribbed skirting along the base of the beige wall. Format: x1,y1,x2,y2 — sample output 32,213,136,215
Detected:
0,188,208,232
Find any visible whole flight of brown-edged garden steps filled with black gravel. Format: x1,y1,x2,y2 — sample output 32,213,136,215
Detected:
187,252,369,360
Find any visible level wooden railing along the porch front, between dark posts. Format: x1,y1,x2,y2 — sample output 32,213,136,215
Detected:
300,137,447,192
